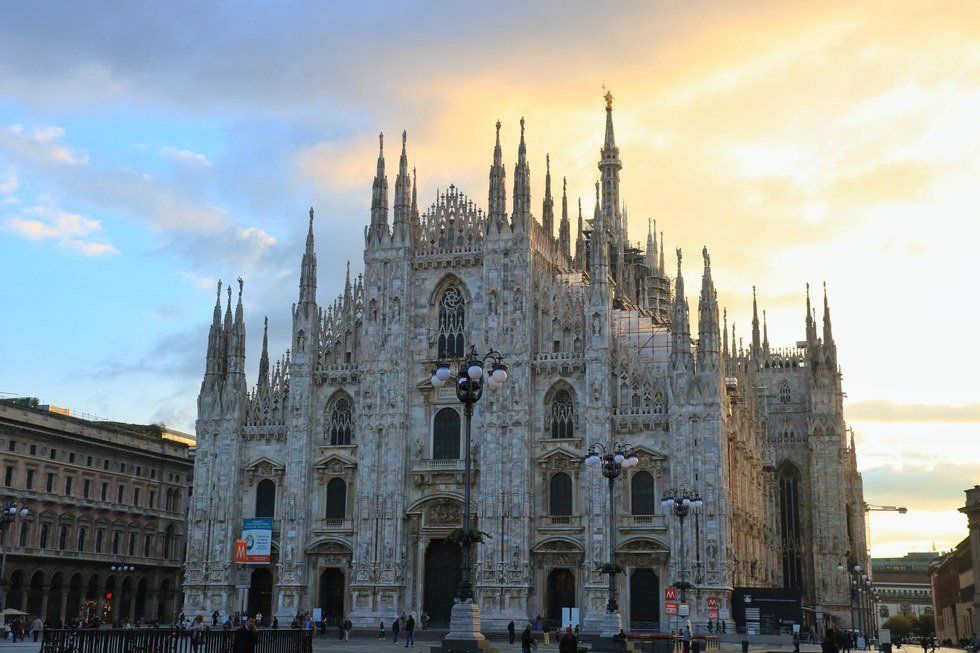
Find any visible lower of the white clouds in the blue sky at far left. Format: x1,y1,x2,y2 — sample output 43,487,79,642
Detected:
4,206,118,258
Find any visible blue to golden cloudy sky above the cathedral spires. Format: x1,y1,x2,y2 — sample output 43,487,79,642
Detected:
0,1,980,555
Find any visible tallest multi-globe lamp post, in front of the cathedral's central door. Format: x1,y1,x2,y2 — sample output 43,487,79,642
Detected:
430,347,507,650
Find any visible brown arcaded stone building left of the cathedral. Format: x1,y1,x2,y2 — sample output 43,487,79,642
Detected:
0,402,193,623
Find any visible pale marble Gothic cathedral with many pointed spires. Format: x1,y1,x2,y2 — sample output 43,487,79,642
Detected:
185,97,867,632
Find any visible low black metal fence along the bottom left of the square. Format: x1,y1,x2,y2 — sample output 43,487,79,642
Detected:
41,628,313,653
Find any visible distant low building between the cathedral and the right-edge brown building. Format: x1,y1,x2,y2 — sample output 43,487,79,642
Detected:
871,551,939,627
